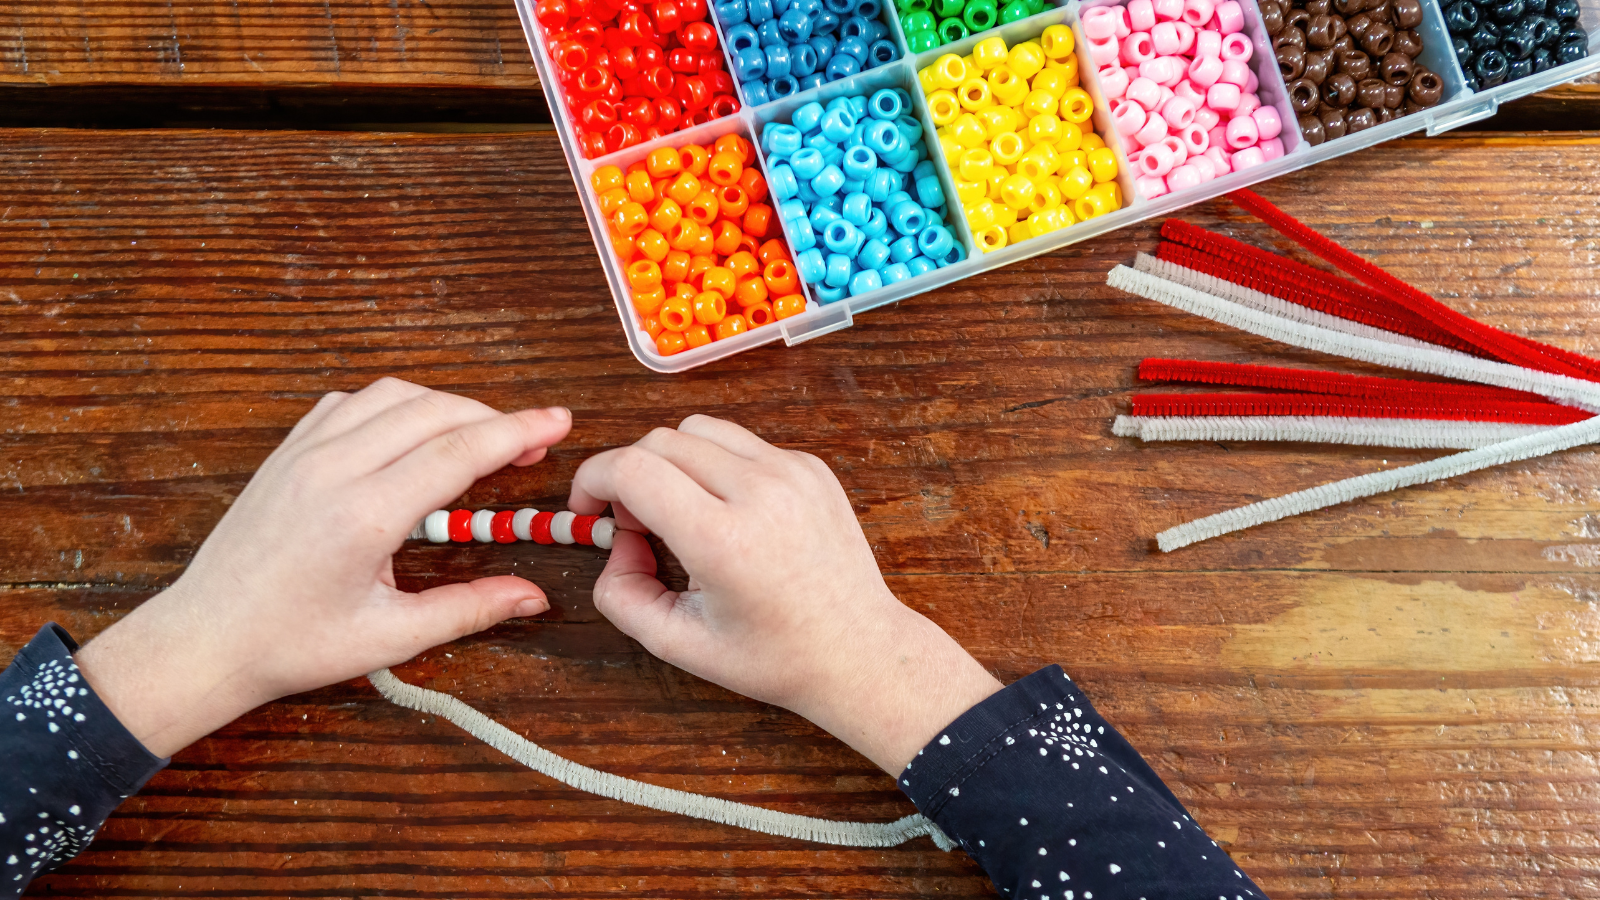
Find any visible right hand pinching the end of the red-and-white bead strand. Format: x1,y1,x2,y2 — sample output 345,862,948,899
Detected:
570,416,1000,773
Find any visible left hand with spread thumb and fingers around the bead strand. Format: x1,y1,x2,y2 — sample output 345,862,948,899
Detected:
77,378,571,756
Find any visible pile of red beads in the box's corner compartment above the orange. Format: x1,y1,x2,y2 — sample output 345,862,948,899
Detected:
534,0,739,159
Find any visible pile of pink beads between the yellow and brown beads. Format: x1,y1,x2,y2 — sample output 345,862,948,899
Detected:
1083,0,1283,199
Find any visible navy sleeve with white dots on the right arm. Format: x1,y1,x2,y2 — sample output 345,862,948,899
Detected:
899,666,1264,900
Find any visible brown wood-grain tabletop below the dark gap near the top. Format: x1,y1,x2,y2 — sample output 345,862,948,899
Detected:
0,128,1600,900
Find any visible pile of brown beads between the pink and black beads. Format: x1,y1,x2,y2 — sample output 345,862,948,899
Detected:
1261,0,1445,146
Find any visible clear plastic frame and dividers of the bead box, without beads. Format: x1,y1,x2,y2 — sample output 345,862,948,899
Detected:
517,0,1600,373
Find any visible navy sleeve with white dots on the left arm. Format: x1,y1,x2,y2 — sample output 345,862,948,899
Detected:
0,625,166,897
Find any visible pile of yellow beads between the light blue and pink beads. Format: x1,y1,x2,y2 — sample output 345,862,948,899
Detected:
920,26,1123,253
